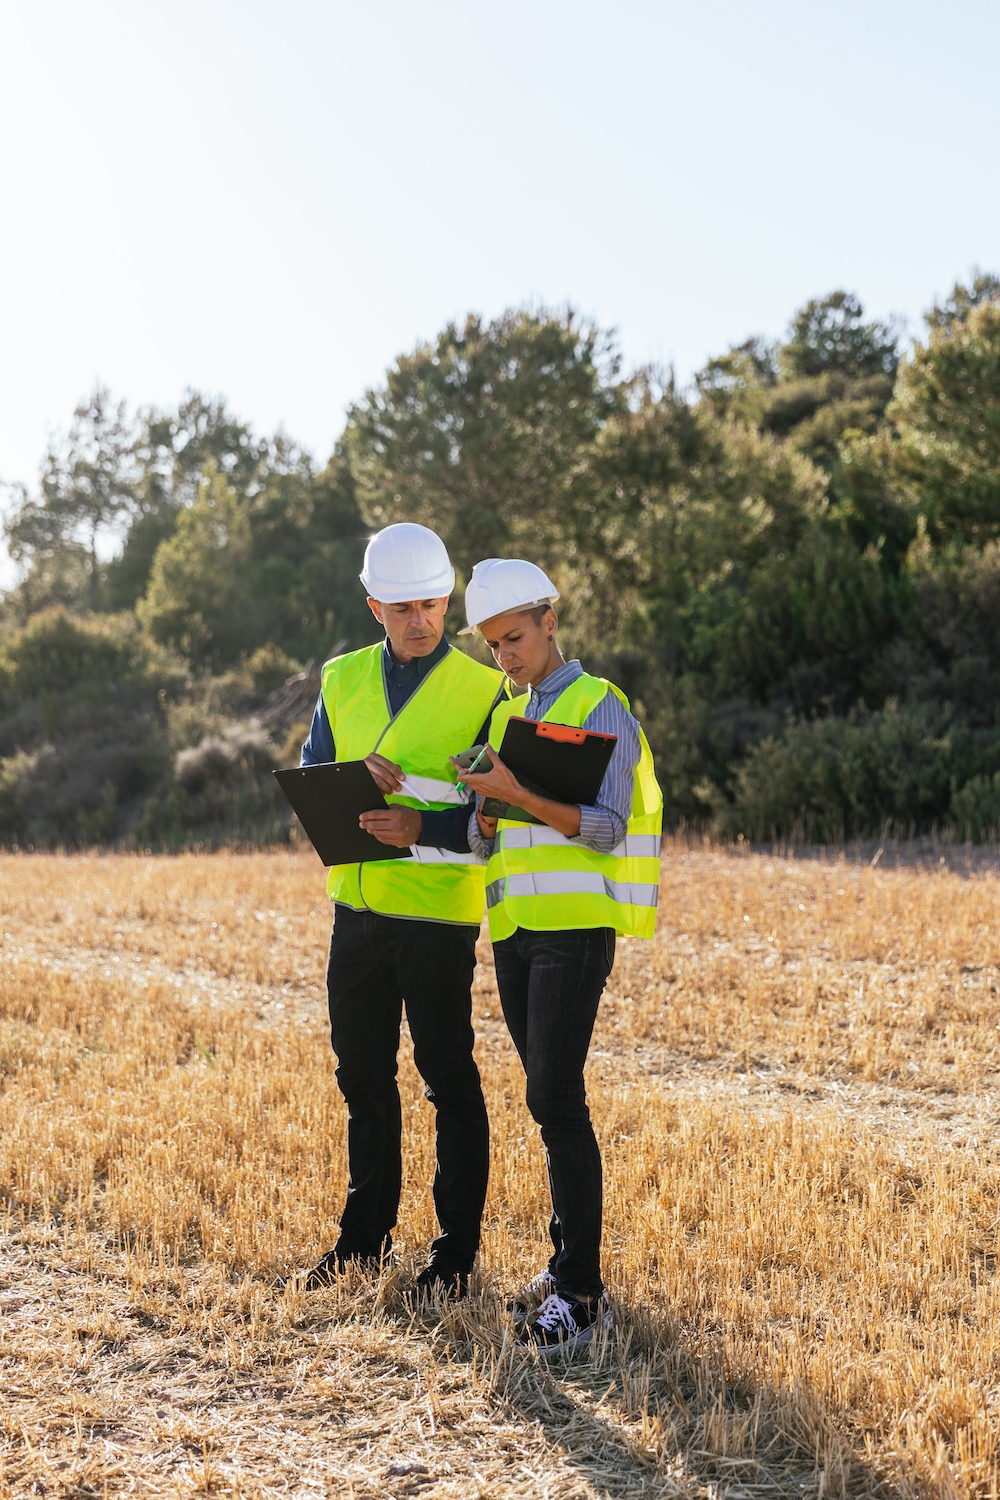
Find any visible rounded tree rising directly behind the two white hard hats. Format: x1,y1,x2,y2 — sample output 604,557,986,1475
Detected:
343,311,627,576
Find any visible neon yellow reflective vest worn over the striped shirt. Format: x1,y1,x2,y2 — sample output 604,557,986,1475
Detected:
486,672,663,942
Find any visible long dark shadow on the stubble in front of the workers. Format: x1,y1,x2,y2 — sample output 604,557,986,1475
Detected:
445,1305,889,1500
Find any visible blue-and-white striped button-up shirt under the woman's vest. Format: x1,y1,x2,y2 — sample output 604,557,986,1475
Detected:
469,662,642,860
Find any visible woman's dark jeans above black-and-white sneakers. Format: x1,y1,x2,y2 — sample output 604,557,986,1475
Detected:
493,927,615,1298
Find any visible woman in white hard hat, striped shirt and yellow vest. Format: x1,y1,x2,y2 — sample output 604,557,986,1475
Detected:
462,558,663,1355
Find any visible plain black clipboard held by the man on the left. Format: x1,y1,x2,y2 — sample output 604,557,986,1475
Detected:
274,761,411,864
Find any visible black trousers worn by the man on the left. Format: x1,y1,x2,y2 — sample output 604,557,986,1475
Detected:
327,906,489,1275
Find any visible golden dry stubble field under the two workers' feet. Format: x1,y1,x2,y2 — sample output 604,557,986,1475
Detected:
0,843,1000,1500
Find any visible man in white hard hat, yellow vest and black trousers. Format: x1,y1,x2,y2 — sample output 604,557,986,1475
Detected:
301,522,504,1296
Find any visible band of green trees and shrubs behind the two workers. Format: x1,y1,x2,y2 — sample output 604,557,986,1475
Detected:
0,275,1000,848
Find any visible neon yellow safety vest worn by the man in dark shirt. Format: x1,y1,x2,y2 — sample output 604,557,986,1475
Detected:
322,645,504,926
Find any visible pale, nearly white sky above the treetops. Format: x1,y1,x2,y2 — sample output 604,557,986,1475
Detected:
0,0,1000,584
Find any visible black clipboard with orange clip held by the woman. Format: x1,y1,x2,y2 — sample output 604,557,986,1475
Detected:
483,716,618,824
